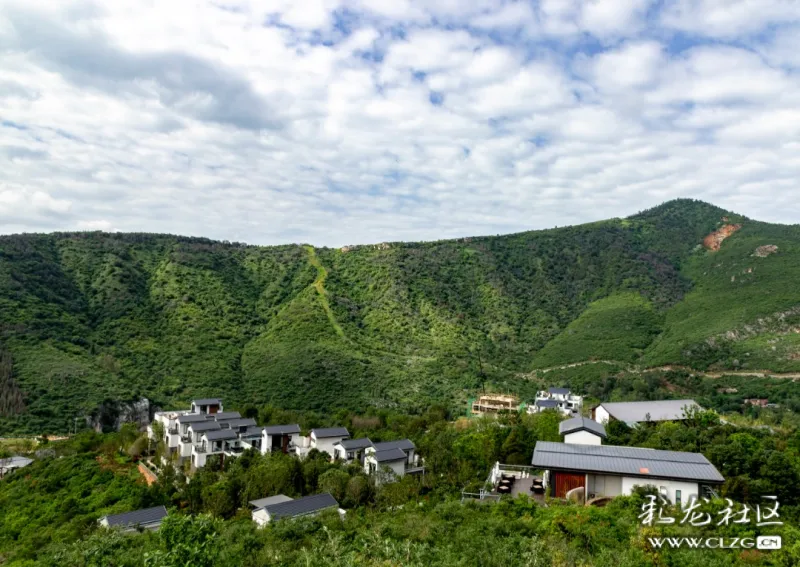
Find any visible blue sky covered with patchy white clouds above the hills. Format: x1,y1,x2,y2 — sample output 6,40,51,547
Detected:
0,0,800,246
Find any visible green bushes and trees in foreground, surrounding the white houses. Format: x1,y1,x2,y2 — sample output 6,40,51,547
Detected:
0,407,800,567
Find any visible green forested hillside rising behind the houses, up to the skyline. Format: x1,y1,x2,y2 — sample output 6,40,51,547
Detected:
0,200,800,433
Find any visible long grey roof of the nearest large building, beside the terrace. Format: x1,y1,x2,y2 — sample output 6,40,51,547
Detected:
533,441,725,483
